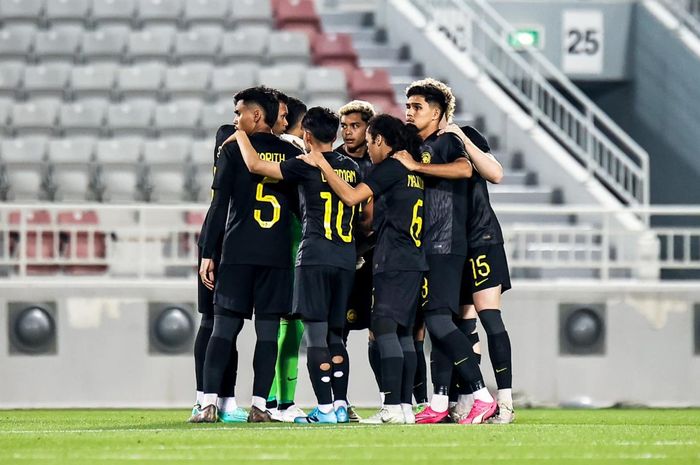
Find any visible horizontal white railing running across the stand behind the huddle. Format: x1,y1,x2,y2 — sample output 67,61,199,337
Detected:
0,204,700,281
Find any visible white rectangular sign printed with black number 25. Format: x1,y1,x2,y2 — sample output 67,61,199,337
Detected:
562,10,604,74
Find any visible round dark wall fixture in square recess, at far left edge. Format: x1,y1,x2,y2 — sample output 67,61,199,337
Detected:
9,305,56,355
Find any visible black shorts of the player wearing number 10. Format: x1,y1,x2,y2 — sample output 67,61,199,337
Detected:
294,265,355,329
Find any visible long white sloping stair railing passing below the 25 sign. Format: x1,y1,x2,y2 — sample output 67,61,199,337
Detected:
412,0,649,206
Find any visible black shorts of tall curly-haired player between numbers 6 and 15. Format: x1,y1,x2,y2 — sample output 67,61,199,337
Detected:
423,254,464,313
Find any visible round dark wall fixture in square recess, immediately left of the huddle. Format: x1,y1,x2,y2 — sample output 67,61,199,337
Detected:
149,305,195,354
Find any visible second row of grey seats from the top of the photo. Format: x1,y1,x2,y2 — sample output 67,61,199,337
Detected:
0,24,311,64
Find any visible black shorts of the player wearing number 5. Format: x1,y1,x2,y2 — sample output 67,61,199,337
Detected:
214,264,292,319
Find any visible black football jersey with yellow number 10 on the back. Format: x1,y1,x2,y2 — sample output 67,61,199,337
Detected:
280,152,360,270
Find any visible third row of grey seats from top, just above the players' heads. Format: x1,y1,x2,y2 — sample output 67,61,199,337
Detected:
0,62,348,100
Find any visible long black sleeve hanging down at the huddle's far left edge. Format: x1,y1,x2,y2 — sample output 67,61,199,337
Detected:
202,144,236,258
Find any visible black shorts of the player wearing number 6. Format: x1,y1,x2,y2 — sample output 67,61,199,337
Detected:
372,271,423,328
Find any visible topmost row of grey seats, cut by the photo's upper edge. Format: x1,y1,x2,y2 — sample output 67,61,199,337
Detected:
0,0,278,26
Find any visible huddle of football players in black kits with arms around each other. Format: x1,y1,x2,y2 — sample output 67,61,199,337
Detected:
190,78,514,424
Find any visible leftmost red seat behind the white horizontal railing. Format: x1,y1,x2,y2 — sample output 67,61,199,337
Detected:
8,210,59,274
